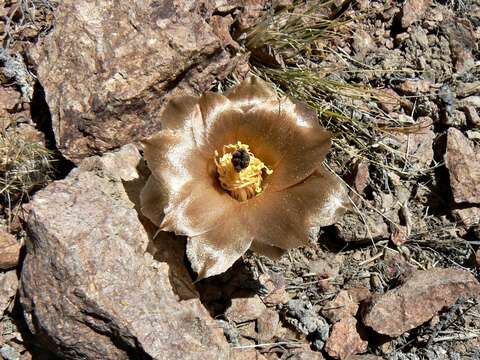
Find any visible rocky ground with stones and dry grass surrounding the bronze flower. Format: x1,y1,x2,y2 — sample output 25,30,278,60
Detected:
0,0,480,360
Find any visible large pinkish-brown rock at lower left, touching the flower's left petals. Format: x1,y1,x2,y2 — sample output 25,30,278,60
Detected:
20,145,230,360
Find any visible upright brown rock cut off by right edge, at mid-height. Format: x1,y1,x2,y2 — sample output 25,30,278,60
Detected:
444,128,480,203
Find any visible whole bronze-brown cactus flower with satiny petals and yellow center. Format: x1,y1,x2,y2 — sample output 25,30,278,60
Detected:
141,77,347,279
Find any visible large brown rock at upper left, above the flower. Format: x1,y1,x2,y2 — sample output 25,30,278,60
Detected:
31,0,246,163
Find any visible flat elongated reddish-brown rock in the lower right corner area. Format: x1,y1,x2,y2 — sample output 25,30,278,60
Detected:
363,269,480,337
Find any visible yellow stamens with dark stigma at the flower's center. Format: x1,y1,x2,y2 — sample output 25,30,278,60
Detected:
214,141,273,201
